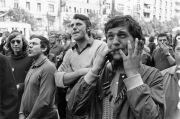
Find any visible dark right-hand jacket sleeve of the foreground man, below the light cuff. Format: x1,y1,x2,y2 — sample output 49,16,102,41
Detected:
127,68,165,119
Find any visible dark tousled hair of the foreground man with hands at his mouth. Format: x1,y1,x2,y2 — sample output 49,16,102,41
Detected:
105,15,143,40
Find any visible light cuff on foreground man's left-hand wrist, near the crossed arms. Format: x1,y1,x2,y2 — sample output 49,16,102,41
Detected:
84,70,100,85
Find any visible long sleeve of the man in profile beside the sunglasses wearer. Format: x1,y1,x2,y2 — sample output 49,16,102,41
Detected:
28,66,56,119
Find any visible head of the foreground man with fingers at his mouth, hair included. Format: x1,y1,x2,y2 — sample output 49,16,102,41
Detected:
105,16,142,61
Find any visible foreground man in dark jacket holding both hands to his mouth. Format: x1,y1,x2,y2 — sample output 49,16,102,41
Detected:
68,16,165,119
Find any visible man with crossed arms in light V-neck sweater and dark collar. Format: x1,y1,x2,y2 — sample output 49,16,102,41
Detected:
55,14,107,119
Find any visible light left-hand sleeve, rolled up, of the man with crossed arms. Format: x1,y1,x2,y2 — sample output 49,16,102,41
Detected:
54,49,72,88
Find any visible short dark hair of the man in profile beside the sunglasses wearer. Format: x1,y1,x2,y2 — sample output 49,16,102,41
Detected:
30,35,50,56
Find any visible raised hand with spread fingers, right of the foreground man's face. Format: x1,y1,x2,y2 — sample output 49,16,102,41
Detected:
120,38,143,77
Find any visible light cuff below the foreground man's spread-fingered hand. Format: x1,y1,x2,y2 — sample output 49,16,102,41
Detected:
124,74,144,91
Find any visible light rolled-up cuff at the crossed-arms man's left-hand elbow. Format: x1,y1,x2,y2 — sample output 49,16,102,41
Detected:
54,71,66,88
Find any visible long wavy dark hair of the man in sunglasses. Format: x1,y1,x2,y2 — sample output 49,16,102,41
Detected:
7,32,28,54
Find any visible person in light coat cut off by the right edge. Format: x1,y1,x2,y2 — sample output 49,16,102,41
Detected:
161,34,180,119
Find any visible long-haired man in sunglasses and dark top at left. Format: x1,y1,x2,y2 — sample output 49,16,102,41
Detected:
7,31,32,109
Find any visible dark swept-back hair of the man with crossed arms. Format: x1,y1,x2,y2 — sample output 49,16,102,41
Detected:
73,14,91,36
